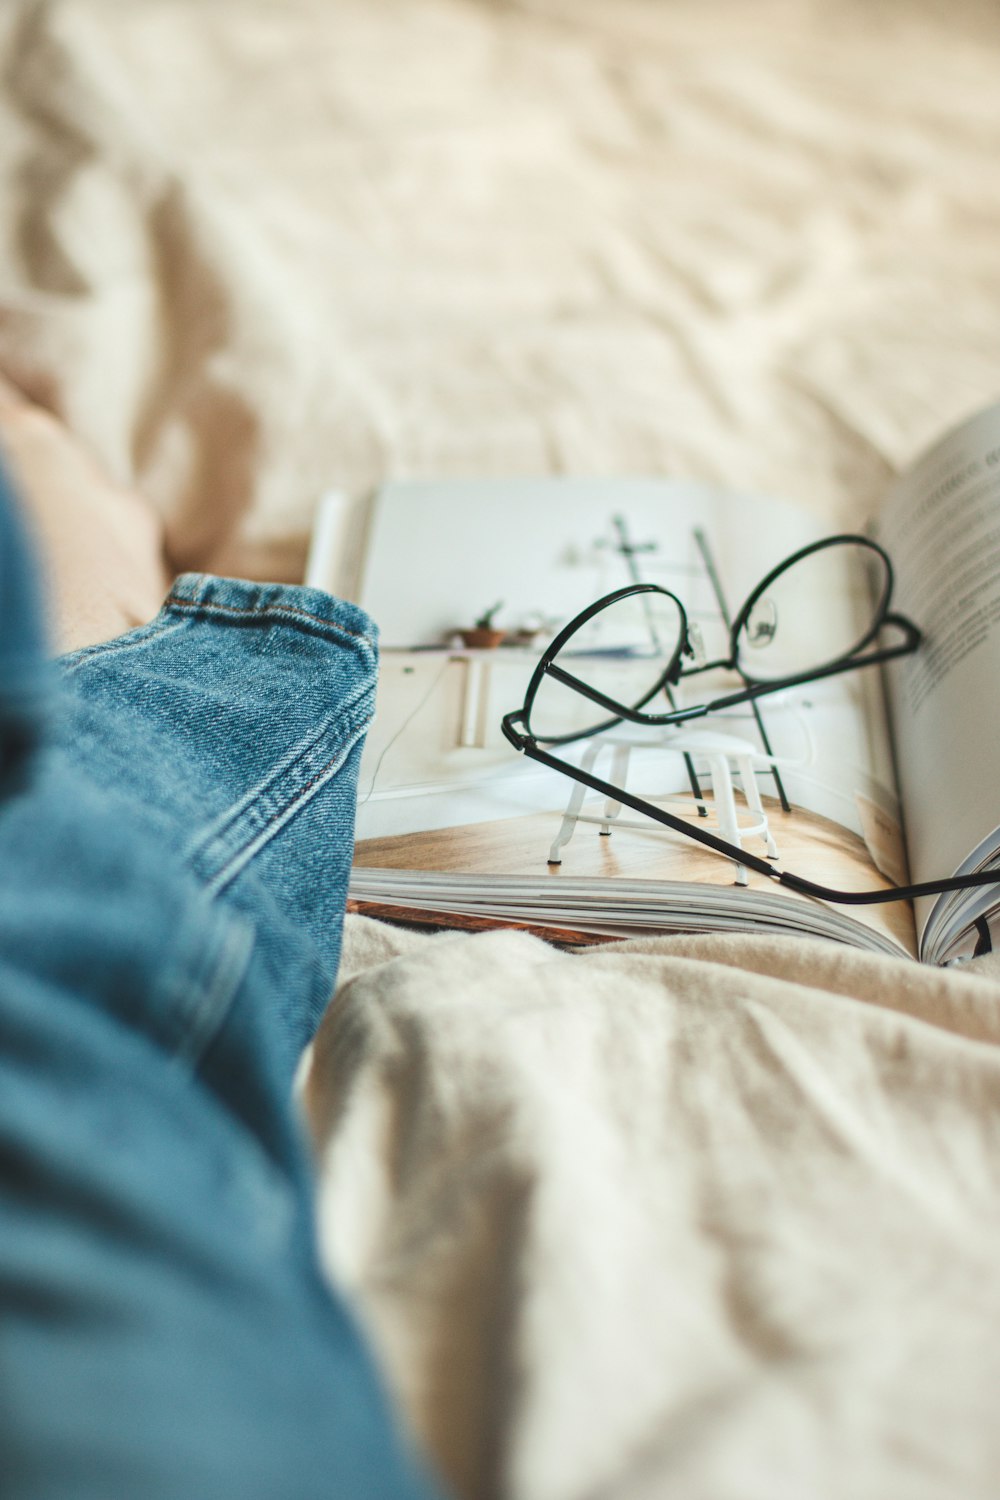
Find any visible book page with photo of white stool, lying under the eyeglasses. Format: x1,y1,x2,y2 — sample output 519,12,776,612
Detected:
355,480,913,951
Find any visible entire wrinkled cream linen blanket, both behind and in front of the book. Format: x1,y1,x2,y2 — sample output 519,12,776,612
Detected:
0,0,1000,1500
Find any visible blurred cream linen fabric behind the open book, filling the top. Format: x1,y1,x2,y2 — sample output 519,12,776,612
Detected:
0,0,1000,579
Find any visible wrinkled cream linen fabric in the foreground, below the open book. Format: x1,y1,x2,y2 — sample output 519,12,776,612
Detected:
314,918,1000,1500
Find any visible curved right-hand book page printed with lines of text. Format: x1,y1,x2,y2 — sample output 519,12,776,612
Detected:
879,407,1000,962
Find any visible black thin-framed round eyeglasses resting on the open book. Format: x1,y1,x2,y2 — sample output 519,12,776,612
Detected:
501,534,1000,906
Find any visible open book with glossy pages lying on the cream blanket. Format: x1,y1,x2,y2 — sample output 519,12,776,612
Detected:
309,407,1000,963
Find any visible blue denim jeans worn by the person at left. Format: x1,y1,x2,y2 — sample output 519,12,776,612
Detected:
0,468,446,1500
